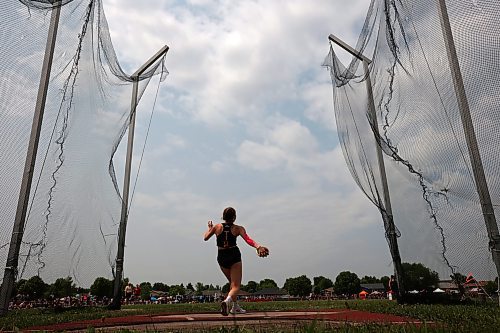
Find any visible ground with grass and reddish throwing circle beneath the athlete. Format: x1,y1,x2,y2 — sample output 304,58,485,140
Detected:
0,300,500,332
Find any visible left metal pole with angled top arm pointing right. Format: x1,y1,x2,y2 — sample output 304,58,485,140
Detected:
109,45,169,310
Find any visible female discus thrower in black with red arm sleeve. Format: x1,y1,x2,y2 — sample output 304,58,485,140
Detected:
203,207,269,316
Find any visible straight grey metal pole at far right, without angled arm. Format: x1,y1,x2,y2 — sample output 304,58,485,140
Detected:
438,0,500,282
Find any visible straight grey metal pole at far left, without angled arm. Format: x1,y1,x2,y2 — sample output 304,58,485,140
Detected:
0,1,61,315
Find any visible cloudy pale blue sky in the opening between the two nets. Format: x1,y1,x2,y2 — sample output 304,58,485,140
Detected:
99,0,392,286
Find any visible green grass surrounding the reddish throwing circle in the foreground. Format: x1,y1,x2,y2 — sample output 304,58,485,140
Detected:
0,300,500,332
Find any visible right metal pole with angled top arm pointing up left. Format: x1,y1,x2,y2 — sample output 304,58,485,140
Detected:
328,35,405,300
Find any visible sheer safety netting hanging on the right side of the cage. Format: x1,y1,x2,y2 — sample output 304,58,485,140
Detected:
324,0,500,280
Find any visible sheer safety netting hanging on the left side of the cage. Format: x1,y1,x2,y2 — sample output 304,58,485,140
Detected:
0,0,168,288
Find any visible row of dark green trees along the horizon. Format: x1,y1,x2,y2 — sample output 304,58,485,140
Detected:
14,263,496,300
